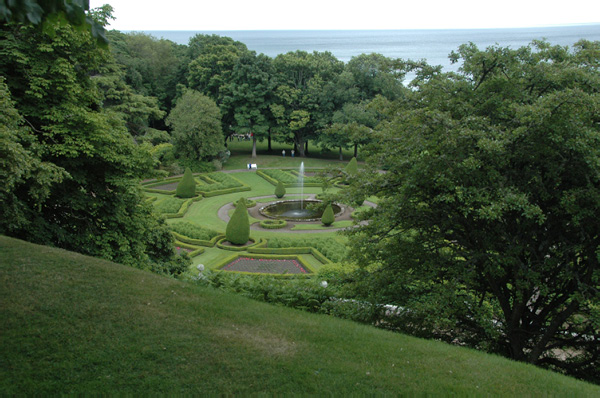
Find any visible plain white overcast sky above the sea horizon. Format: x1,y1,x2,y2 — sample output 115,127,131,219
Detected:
90,0,600,30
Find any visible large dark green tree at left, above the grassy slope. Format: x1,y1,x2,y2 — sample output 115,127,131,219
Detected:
0,12,183,268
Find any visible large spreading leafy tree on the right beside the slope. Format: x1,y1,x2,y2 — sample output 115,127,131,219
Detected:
351,41,600,381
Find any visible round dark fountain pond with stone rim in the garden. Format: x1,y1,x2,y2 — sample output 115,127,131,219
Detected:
259,199,344,221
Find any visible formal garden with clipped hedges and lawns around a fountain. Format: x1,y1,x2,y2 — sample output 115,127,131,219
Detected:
143,158,377,277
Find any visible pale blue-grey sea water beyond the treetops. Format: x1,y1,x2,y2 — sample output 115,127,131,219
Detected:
138,25,600,70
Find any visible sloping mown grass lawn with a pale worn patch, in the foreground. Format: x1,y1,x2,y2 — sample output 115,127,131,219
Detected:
0,237,600,396
